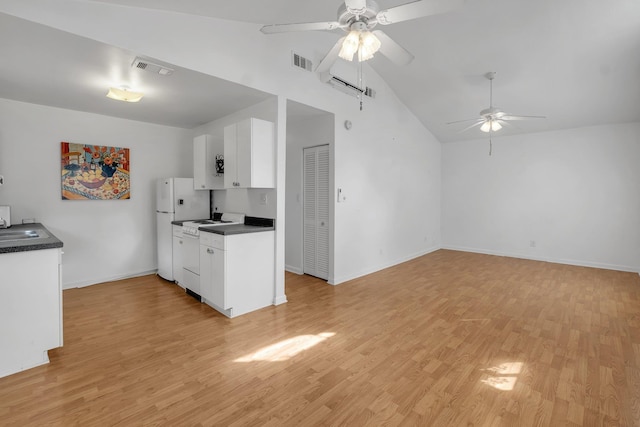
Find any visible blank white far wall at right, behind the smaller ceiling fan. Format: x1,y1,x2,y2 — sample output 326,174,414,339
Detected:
442,123,640,271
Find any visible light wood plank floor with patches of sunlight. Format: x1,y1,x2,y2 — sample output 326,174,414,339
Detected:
0,250,640,426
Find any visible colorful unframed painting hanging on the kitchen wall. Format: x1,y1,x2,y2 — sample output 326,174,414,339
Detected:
60,142,131,200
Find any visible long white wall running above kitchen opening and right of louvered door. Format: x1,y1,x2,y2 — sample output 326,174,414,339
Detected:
0,0,441,283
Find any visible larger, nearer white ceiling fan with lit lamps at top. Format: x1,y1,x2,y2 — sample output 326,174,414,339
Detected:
260,0,465,72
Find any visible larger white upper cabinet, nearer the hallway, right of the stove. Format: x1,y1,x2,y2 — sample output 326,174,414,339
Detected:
224,118,276,188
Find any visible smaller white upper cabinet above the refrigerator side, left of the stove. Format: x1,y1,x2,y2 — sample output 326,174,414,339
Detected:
193,135,224,190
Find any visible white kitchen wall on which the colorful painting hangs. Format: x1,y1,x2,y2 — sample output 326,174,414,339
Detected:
0,99,193,288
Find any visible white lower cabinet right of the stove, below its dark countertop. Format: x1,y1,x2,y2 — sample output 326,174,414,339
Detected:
200,230,275,317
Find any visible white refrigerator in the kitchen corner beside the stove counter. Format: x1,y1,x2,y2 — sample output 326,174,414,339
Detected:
156,178,211,281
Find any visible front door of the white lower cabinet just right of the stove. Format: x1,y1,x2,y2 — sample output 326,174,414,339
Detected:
200,245,229,309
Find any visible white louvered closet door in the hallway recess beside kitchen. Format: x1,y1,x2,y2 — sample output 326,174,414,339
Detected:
303,145,329,280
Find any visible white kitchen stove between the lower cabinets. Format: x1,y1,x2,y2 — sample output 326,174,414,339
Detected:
182,213,244,300
